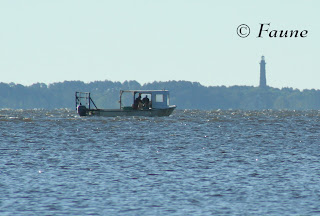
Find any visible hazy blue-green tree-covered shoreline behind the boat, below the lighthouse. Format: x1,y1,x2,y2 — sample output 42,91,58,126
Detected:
0,80,320,110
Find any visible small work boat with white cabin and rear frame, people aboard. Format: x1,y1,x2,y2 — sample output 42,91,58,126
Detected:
75,90,177,117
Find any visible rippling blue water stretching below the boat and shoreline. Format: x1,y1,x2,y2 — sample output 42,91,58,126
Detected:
0,110,320,215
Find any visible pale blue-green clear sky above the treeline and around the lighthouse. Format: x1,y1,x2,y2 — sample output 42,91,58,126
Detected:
0,0,320,90
